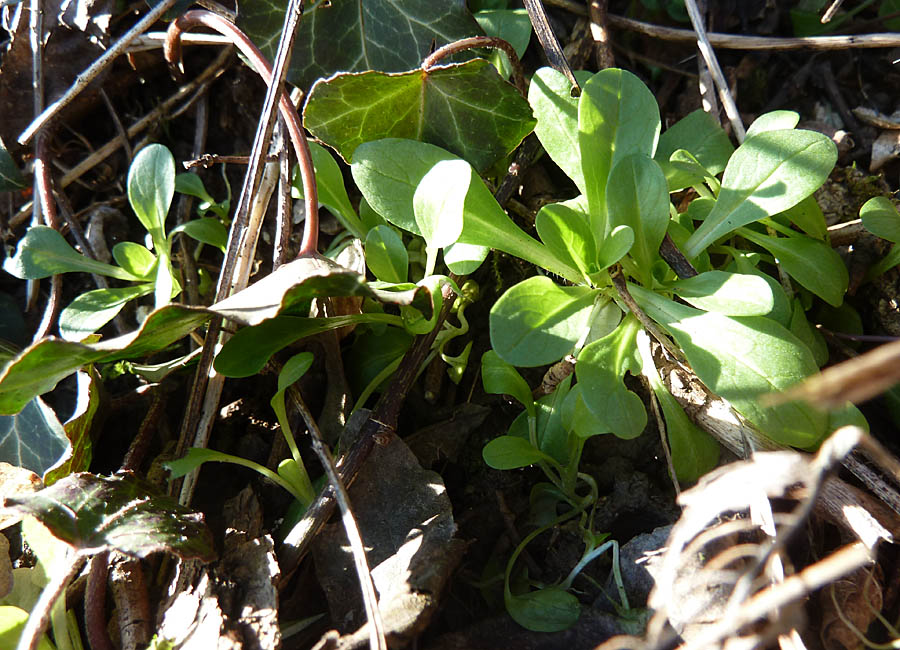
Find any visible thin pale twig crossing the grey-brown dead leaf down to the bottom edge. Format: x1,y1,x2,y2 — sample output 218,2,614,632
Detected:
288,384,387,650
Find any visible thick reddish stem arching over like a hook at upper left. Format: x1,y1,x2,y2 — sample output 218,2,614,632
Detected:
163,9,319,257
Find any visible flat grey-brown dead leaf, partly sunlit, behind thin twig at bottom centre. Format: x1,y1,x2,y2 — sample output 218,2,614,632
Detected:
313,438,464,647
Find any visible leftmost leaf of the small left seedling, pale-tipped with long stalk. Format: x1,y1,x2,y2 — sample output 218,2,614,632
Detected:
3,226,140,281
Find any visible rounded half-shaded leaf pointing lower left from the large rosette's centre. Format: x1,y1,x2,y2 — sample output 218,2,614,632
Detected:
490,276,596,368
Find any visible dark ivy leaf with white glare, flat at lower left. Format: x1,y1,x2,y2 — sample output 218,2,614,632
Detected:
3,472,215,562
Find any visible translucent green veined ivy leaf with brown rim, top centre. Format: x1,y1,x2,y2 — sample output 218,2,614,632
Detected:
303,59,535,171
